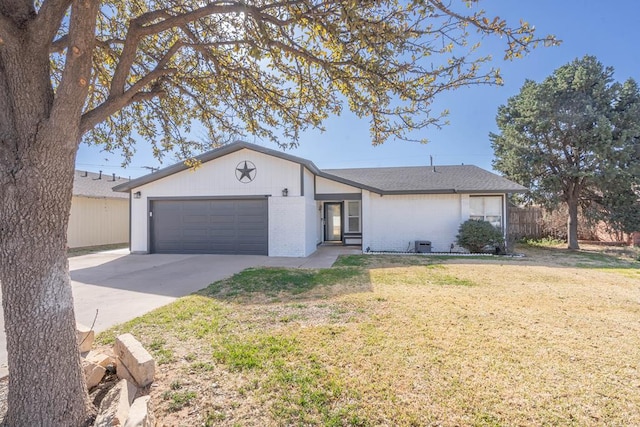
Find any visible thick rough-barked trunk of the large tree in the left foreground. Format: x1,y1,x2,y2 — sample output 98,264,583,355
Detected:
0,5,94,426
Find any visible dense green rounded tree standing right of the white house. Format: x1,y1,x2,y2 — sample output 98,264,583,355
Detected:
490,56,640,249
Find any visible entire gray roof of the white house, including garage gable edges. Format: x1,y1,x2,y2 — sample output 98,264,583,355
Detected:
113,141,527,194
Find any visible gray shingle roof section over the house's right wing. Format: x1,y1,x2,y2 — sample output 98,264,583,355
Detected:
322,165,527,194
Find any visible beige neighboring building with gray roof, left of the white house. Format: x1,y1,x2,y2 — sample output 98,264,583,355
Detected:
67,171,129,248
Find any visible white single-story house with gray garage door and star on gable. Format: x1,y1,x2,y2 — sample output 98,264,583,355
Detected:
114,142,526,257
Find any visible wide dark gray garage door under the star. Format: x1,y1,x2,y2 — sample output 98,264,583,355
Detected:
151,198,269,255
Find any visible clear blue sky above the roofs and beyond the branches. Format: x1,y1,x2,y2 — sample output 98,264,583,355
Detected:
76,0,640,178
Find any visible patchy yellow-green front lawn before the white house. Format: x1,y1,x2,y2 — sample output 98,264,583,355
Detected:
99,248,640,426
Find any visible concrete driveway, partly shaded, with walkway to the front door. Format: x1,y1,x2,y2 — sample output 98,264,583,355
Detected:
0,246,361,378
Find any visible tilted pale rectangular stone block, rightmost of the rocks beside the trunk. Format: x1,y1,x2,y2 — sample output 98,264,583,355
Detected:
113,334,156,387
